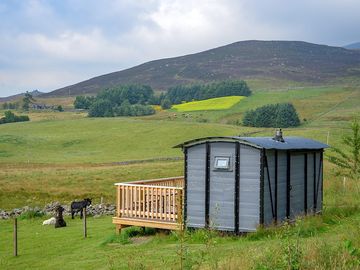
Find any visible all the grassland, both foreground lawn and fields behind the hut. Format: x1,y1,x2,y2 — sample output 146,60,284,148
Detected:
0,84,360,269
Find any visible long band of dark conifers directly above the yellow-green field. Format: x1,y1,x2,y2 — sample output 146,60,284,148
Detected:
164,80,251,104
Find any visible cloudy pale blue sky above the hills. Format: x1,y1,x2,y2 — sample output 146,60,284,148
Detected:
0,0,360,96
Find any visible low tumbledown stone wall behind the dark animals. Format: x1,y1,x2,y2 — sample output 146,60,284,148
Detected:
0,202,115,219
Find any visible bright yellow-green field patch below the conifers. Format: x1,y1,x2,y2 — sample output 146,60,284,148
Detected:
171,96,245,112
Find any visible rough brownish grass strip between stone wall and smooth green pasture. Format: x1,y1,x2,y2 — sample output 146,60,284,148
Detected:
0,161,183,209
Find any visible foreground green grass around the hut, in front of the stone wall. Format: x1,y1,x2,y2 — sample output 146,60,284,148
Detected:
0,172,360,269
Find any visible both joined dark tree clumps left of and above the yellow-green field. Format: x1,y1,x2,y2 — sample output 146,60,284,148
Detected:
74,80,251,117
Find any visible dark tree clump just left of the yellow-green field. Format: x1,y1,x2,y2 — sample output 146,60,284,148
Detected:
74,85,156,117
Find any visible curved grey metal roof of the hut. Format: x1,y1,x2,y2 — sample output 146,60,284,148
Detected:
174,137,329,150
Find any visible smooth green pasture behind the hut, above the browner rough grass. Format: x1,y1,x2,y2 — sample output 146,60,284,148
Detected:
0,118,245,164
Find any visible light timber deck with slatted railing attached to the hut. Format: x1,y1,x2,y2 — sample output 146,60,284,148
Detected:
113,176,184,233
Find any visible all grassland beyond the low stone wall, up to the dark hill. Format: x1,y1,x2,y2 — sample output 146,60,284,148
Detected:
0,84,360,209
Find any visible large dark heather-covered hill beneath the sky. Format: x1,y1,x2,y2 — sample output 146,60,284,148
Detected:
44,41,360,96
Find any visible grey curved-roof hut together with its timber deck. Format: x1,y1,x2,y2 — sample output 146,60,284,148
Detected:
113,132,328,233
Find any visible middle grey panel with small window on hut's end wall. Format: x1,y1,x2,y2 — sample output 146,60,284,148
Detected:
209,142,235,231
